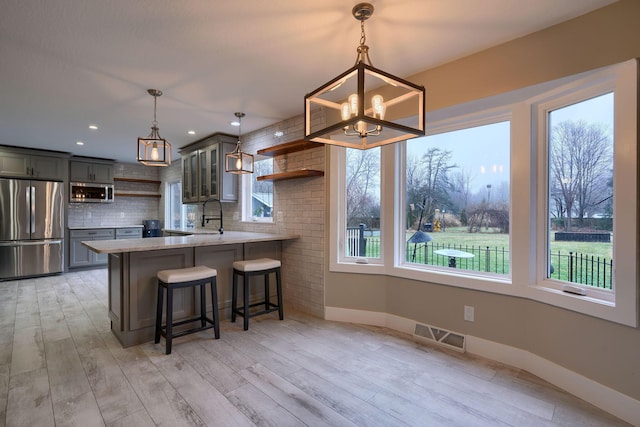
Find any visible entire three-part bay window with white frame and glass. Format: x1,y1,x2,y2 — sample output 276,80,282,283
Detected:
329,60,638,327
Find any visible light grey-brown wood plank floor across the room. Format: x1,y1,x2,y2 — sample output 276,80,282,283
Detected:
0,270,624,427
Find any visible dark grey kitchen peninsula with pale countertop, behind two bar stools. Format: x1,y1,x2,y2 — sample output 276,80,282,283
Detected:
82,231,298,347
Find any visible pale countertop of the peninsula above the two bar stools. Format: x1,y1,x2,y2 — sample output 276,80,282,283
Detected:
82,231,300,254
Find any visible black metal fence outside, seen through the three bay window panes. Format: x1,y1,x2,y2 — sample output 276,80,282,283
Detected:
346,229,613,289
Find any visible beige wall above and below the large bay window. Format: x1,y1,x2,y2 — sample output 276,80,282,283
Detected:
325,0,640,400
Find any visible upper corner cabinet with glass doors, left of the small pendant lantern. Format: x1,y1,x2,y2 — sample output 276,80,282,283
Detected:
180,133,238,203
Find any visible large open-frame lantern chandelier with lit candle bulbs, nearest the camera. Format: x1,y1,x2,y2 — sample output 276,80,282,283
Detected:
304,3,425,149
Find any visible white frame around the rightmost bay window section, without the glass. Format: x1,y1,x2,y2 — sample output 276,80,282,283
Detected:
526,60,638,327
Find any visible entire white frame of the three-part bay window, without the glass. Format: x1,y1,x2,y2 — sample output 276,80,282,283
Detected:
328,59,638,327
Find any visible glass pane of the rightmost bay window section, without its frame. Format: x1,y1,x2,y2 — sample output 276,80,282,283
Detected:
547,92,615,292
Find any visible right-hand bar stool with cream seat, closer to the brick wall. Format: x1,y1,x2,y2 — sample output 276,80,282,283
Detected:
231,258,284,331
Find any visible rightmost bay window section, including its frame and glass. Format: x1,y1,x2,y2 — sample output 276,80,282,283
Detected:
528,60,638,326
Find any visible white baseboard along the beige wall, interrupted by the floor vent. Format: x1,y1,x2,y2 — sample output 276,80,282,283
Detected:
324,307,640,425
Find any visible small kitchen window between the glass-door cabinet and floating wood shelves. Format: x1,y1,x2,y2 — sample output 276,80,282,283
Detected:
242,157,273,222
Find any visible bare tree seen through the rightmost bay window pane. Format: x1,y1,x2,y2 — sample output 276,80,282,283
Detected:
549,120,612,229
